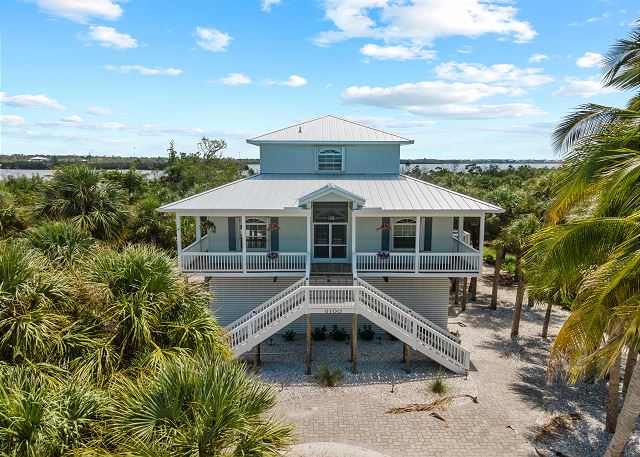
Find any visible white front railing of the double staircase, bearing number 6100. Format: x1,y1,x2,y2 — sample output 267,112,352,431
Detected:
228,279,470,373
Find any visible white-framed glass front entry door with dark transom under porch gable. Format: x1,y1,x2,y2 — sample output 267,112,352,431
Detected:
313,202,349,262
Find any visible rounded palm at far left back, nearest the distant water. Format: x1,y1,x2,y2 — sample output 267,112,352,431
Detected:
35,165,127,239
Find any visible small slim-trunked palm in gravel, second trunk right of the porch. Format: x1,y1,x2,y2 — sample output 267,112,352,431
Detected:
501,214,542,336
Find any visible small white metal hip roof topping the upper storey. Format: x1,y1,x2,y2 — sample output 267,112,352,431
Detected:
247,115,413,144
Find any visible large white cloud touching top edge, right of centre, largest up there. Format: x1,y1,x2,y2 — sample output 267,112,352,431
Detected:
315,0,536,46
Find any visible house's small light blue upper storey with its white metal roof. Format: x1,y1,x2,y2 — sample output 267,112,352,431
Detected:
247,116,413,174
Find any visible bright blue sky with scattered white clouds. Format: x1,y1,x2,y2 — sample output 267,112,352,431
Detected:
0,0,640,159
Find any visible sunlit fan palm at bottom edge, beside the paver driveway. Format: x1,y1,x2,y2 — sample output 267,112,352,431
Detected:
108,353,291,456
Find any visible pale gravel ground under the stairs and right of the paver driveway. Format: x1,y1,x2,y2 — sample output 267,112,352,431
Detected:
248,270,640,457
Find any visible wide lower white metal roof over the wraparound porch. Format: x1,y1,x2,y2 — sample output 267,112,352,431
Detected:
159,173,503,213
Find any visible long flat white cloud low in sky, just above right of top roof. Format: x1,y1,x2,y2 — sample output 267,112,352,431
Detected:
342,81,542,119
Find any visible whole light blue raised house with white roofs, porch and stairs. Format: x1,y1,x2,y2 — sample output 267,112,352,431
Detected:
160,116,502,372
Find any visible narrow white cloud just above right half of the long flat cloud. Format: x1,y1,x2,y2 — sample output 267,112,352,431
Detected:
436,62,553,87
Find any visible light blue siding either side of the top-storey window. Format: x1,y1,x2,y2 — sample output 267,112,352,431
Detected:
260,144,400,174
